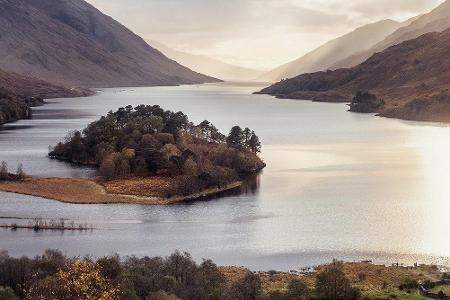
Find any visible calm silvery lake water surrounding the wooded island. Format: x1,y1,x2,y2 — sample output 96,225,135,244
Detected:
0,84,450,270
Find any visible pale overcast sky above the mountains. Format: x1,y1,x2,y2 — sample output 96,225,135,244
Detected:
87,0,443,69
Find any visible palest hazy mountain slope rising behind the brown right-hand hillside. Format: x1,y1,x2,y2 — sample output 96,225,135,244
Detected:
259,20,402,81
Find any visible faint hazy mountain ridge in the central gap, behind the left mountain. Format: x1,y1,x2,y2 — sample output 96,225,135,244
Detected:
149,41,264,81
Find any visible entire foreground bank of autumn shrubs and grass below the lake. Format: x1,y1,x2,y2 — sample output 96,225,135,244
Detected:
0,250,450,300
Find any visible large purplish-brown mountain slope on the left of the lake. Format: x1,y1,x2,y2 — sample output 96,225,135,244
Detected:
0,0,216,87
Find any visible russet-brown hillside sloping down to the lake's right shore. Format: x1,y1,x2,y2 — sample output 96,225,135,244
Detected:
261,29,450,122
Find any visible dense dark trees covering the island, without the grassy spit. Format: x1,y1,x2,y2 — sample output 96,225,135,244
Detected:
49,105,265,194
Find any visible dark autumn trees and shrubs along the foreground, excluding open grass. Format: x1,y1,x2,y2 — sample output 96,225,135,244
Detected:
0,250,361,300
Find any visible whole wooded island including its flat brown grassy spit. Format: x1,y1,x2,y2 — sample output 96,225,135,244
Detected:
0,105,265,204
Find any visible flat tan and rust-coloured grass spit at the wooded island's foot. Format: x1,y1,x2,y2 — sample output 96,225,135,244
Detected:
0,177,241,205
